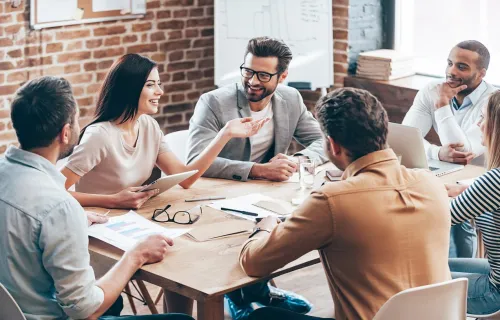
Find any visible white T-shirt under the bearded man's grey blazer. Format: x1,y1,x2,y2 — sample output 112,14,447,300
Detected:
250,101,274,162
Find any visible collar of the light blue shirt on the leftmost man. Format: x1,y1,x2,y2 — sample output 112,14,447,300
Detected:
5,146,66,187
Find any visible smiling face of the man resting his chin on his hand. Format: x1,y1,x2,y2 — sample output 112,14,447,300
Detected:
446,47,484,95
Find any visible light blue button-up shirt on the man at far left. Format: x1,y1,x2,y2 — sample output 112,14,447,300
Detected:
0,147,104,319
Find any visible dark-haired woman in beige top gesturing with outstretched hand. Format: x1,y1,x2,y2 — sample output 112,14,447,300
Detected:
62,54,269,208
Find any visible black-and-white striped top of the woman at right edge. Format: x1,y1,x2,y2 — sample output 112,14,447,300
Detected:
451,168,500,288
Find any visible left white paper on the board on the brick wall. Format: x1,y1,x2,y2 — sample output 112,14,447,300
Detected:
36,0,78,23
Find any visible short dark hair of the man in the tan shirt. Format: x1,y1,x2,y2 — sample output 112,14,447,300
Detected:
316,88,388,161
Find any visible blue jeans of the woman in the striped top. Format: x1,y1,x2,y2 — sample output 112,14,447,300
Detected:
448,258,500,315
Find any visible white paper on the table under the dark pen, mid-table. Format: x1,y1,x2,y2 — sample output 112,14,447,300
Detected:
209,193,295,221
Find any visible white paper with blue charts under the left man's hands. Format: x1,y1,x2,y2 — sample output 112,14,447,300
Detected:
89,211,191,251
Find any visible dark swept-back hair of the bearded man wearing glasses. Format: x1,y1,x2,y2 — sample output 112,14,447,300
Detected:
244,37,293,73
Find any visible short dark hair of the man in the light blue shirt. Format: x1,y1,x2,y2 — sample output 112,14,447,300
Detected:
11,76,77,150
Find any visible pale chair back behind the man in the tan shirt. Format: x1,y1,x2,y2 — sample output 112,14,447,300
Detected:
373,278,468,320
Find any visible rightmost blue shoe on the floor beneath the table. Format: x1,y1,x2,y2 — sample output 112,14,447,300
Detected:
252,286,313,314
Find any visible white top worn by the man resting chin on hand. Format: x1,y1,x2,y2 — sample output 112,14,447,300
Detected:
403,81,498,160
